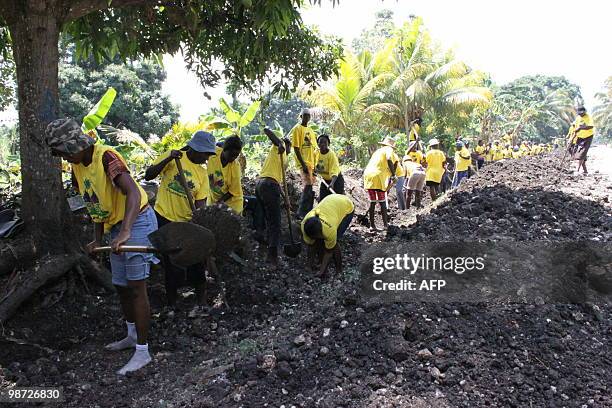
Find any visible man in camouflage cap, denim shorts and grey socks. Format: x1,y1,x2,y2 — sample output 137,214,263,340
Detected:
45,119,157,375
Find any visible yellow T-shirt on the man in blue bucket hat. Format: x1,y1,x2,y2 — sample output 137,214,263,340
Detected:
153,151,209,222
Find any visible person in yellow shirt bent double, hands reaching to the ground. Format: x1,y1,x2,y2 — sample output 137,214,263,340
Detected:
301,194,355,278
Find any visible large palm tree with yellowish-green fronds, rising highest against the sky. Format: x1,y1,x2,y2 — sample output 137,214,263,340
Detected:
368,18,491,135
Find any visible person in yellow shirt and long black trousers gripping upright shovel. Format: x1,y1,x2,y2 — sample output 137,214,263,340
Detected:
255,128,291,268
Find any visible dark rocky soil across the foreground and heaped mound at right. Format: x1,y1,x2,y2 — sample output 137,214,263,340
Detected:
0,151,612,408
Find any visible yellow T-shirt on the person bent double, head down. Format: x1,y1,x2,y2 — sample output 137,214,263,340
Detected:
302,194,355,249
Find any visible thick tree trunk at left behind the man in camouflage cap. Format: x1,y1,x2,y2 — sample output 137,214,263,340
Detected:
9,7,69,252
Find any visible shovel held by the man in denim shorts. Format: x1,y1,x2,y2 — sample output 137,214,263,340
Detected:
93,222,216,267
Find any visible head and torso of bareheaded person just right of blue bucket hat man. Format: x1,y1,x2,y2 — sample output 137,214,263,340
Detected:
207,136,244,214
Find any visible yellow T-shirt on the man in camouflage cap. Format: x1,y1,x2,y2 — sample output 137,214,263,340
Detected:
72,144,148,232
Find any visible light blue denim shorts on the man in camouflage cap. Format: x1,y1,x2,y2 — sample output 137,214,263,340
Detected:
110,206,159,286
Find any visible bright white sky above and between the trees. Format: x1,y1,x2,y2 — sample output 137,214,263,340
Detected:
0,0,612,121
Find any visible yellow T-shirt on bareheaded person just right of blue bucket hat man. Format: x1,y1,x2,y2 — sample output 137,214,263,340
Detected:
207,146,244,214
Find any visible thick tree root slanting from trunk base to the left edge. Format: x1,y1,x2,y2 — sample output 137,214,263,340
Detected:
0,253,87,323
